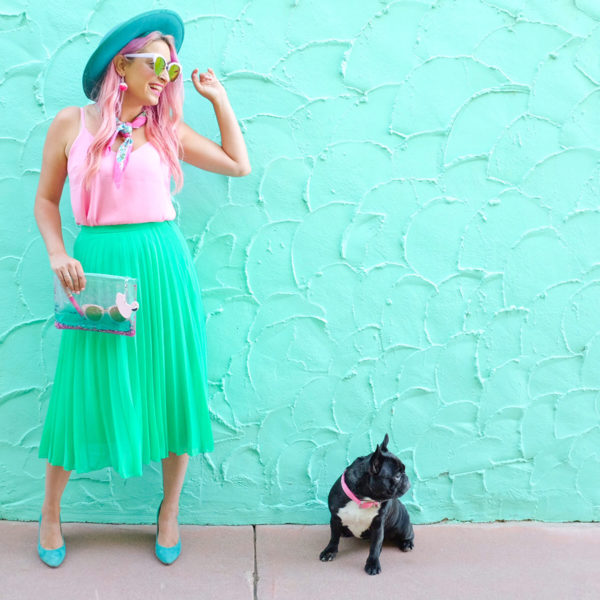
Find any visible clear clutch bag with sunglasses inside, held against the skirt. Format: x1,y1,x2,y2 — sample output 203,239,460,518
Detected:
54,273,139,335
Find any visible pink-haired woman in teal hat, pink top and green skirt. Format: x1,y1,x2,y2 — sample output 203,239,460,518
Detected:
35,10,250,566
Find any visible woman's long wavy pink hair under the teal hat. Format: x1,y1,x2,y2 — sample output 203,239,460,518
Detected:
83,31,183,191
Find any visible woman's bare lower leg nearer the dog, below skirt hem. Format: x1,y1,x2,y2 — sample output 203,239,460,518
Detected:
158,452,190,547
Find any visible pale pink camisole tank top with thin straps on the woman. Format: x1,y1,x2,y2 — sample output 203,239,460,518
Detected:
67,108,175,225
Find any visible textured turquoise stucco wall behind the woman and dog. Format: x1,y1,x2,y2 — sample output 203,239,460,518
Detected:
0,0,600,523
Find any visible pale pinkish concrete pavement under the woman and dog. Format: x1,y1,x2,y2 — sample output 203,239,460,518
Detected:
0,521,600,600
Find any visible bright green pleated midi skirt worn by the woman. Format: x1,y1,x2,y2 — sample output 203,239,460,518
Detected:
39,221,213,477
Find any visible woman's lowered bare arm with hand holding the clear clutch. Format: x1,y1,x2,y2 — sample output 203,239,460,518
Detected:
33,106,85,292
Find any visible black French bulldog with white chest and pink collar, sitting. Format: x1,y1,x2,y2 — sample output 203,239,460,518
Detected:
319,433,415,575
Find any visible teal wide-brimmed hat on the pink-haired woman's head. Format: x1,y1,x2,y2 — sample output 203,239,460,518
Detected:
82,9,183,100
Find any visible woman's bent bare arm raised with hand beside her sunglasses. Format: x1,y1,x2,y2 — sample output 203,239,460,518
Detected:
179,69,250,177
